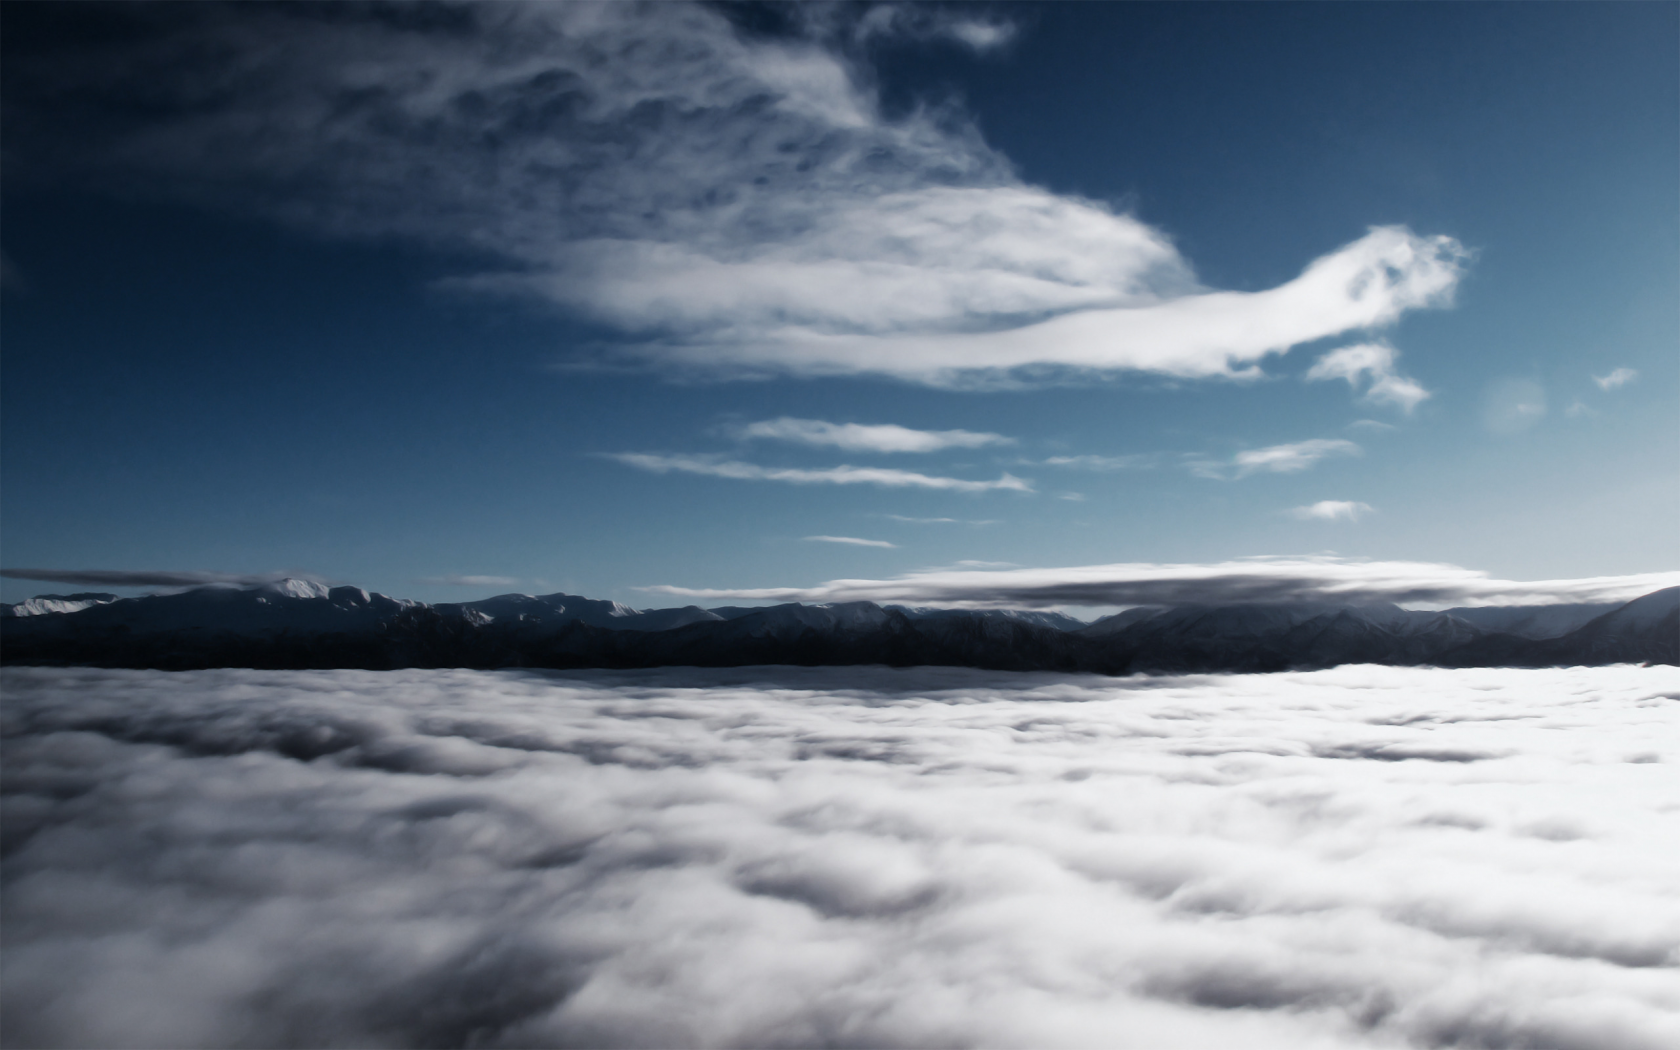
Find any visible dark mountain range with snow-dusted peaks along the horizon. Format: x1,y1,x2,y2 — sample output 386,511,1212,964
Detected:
0,580,1680,674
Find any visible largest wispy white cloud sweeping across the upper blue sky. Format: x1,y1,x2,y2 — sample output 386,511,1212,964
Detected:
8,3,1467,389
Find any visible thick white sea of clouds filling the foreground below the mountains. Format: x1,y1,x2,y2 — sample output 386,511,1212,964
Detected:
3,667,1680,1050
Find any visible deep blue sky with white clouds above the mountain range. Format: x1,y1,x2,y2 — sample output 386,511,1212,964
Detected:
0,3,1680,606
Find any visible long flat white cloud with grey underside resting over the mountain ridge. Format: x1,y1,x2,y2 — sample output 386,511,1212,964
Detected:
640,556,1680,608
